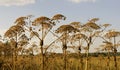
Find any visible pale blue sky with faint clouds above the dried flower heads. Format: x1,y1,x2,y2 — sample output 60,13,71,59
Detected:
0,0,120,52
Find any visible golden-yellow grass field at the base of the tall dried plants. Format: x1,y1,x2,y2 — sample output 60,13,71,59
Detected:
0,54,120,70
